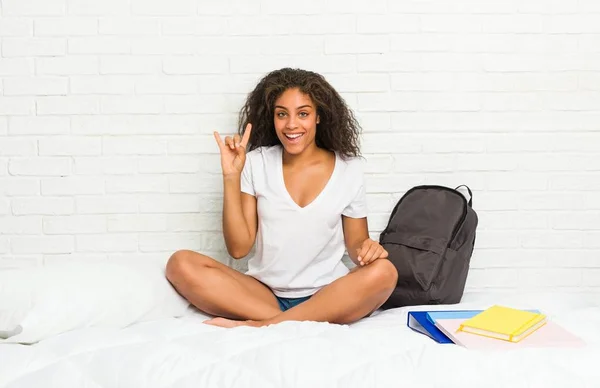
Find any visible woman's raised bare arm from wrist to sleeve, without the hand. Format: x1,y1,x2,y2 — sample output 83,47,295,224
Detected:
223,174,258,259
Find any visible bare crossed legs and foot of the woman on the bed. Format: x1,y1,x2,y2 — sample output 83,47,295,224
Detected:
167,250,398,327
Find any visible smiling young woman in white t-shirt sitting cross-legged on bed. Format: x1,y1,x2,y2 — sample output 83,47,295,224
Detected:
166,68,397,327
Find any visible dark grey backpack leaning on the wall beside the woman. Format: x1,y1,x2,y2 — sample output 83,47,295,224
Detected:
379,185,478,309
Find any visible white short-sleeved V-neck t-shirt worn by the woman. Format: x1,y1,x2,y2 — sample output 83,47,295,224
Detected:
241,145,367,298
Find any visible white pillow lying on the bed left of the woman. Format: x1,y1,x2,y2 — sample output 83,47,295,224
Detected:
0,262,189,344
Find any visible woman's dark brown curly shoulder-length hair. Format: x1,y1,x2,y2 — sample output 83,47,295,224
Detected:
238,68,361,157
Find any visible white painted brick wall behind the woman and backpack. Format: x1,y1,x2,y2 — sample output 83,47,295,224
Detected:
0,0,600,292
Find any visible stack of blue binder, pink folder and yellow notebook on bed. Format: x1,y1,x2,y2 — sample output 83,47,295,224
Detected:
407,305,583,349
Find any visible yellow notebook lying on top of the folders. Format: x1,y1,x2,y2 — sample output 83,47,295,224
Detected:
458,305,546,342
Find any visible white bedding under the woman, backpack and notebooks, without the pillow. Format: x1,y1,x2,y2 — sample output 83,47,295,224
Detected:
0,294,600,388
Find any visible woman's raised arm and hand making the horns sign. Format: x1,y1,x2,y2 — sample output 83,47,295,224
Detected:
214,124,258,259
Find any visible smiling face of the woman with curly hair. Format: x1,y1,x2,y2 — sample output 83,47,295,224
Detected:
274,88,319,155
